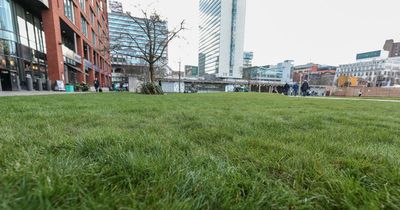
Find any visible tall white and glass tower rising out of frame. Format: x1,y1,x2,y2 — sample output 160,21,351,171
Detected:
199,0,246,78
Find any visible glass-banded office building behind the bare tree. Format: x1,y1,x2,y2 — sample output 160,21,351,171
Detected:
108,5,169,83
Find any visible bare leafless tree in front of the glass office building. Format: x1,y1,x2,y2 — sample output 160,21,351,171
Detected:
110,10,185,83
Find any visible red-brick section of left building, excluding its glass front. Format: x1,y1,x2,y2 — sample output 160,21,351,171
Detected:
42,0,111,86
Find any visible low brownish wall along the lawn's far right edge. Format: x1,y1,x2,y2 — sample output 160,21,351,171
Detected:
334,87,400,97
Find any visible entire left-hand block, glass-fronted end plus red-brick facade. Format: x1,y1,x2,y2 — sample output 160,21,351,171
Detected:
0,0,111,90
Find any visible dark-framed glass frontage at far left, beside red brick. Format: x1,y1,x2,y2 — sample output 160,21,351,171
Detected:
0,0,47,91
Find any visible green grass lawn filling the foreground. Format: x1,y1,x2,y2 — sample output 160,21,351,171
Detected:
0,93,400,209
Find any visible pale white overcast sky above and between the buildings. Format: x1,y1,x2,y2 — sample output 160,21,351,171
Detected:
114,0,400,70
